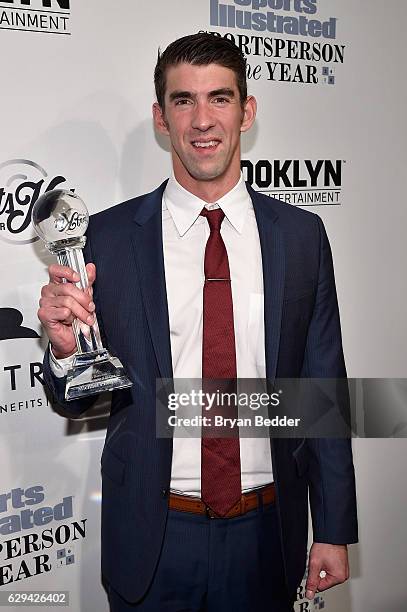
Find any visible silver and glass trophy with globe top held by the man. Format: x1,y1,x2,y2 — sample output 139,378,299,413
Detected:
32,189,132,400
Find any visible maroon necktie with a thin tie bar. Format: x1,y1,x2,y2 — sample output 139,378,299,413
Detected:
201,208,241,516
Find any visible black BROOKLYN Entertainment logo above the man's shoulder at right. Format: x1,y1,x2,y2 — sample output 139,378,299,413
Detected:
241,159,346,206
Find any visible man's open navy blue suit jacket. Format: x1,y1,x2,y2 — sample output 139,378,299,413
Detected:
44,183,358,601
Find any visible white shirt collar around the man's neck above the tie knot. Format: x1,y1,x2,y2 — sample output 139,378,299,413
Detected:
163,174,252,236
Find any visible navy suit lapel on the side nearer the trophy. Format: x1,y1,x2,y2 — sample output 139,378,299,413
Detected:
132,182,173,378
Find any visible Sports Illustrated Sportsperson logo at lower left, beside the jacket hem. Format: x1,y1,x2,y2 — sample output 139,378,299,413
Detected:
0,484,87,587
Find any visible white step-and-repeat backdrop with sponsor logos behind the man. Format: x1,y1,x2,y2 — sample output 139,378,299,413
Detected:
0,0,407,612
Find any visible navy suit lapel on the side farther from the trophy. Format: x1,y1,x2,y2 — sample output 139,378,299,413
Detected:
248,185,285,381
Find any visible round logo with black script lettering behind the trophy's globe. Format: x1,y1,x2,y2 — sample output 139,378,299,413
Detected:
0,159,74,245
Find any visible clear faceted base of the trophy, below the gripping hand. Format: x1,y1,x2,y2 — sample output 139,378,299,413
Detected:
65,350,133,401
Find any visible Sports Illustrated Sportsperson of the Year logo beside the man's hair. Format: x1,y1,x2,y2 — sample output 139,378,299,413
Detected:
209,0,345,85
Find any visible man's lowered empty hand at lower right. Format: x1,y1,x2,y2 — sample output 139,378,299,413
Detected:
305,542,349,599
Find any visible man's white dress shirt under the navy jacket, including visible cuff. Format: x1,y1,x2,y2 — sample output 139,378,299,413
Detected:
51,177,273,497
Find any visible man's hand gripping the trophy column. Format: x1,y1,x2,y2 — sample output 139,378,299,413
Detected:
37,264,96,359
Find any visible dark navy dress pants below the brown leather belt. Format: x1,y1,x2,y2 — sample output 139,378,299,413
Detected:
109,504,294,612
